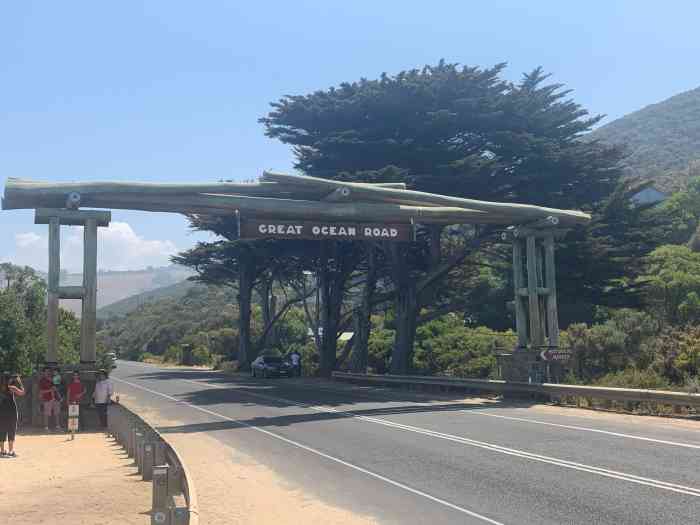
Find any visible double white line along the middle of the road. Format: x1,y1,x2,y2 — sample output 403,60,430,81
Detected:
181,379,700,497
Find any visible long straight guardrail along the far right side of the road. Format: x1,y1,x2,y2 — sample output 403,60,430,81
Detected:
333,372,700,410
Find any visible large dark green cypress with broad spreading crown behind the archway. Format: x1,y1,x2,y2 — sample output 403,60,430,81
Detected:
260,61,622,372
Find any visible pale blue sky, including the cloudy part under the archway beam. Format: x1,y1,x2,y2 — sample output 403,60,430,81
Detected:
0,0,700,269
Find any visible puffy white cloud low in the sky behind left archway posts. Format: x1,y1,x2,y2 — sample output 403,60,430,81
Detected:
4,222,178,272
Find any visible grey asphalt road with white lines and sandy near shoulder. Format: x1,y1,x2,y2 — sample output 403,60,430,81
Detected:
112,361,700,525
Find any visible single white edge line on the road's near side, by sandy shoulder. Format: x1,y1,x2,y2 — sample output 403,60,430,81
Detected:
113,377,505,525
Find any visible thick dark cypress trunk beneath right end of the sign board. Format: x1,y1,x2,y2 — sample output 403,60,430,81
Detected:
390,243,418,374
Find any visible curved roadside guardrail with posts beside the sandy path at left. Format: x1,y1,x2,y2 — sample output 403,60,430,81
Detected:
109,404,199,525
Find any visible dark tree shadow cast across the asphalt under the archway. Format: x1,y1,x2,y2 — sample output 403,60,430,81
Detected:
129,370,535,433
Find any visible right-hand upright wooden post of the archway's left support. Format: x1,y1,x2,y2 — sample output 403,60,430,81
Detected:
80,219,97,363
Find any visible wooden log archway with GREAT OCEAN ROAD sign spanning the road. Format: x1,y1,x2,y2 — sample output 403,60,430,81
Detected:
2,172,591,380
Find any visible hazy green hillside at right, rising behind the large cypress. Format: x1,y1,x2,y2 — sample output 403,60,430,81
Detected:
589,88,700,191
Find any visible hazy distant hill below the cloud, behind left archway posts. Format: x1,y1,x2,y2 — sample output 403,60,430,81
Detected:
50,265,193,316
